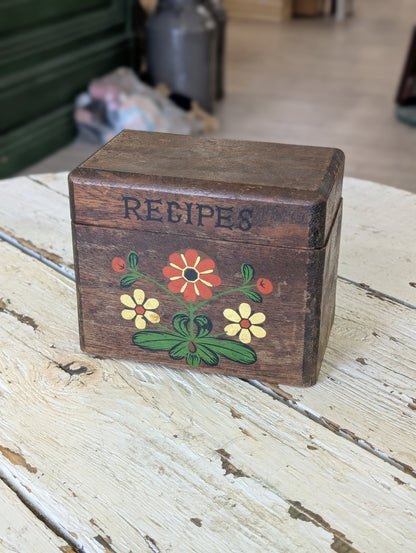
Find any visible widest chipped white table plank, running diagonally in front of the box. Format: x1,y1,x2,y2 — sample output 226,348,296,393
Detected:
0,243,416,553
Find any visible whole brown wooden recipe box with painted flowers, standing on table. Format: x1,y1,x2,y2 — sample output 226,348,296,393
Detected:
69,131,344,386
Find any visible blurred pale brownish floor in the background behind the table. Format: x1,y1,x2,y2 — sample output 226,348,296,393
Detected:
23,0,416,193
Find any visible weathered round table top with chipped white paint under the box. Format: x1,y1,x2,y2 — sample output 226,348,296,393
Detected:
0,174,416,553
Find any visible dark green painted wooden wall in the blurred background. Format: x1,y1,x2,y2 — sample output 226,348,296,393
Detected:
0,0,135,178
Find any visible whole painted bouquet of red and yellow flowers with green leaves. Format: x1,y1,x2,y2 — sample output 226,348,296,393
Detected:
111,248,273,369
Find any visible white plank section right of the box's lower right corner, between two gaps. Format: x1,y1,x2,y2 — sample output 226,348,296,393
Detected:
277,281,416,470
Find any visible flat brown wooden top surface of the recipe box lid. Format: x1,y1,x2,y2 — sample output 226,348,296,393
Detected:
75,130,344,194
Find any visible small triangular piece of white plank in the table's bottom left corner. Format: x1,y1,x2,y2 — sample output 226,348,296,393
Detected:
0,479,70,553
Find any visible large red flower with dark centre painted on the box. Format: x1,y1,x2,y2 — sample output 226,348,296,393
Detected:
163,250,221,302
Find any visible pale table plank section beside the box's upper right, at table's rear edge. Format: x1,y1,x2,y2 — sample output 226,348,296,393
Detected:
338,178,416,306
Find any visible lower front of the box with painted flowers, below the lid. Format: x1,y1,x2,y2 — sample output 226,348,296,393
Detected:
73,225,317,385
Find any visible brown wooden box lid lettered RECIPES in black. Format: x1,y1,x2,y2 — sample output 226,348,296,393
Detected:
69,130,344,249
